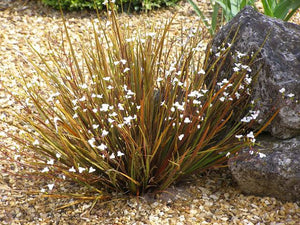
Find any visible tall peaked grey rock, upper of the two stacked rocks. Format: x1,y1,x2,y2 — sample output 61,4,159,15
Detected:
205,6,300,139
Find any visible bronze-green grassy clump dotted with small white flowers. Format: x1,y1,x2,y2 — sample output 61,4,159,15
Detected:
1,8,270,195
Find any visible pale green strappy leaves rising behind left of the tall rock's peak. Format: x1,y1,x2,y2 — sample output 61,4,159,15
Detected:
188,0,255,36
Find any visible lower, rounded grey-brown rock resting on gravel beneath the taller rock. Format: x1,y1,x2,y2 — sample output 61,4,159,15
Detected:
229,137,300,201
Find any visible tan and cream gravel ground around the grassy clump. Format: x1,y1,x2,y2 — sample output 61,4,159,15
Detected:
0,0,300,225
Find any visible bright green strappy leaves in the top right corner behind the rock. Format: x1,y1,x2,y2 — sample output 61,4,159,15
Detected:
262,0,300,21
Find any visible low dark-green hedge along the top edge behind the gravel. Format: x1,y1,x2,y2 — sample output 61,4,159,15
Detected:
42,0,179,11
